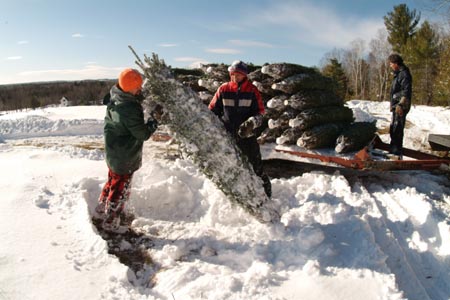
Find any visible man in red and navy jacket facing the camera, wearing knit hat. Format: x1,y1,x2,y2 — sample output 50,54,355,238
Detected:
209,61,272,197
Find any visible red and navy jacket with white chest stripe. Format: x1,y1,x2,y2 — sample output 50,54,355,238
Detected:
208,78,265,135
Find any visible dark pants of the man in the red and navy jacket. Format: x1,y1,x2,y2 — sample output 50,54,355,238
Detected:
236,136,272,198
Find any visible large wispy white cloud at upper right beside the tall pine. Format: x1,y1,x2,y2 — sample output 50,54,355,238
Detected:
252,2,384,47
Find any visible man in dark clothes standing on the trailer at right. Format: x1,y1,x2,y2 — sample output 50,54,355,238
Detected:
389,54,412,159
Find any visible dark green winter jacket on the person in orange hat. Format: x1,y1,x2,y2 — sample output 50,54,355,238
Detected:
104,86,153,175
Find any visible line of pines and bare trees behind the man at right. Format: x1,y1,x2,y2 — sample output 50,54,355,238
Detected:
321,0,450,106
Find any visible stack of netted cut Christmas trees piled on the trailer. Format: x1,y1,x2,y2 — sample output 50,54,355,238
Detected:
172,63,376,153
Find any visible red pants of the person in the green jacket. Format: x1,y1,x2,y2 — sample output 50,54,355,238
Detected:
98,170,133,216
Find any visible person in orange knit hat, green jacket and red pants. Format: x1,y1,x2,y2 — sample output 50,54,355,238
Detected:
96,69,157,230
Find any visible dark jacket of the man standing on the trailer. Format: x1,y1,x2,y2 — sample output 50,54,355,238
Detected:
391,65,412,112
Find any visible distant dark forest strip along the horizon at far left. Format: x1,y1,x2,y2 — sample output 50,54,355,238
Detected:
0,80,116,111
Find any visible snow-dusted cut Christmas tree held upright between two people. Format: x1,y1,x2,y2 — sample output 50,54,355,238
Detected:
130,47,279,222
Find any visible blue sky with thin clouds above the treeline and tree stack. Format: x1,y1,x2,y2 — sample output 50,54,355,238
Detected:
0,0,427,84
